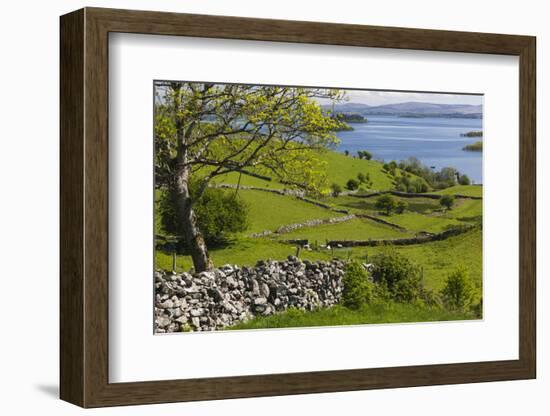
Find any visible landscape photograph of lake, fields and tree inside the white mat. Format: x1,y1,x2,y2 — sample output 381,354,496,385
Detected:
152,80,483,334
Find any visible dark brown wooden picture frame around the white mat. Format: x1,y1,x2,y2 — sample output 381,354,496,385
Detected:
60,8,536,407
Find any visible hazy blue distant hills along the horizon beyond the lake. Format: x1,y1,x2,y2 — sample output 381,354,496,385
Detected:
323,101,483,118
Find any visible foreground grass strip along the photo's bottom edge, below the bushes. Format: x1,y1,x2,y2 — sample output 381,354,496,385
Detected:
228,303,474,329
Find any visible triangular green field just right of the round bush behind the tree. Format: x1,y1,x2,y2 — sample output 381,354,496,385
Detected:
239,189,344,234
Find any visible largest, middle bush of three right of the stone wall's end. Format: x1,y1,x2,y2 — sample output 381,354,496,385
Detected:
372,250,426,302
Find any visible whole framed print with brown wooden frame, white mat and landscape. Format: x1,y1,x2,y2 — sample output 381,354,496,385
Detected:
60,8,536,407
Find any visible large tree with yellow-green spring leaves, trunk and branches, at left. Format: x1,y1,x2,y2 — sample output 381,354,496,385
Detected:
155,82,342,271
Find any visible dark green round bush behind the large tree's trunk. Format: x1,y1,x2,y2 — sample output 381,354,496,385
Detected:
159,188,248,247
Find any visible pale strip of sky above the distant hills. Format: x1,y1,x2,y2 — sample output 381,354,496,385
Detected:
320,90,483,106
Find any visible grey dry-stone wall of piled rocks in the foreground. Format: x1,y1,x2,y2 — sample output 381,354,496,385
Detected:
155,256,344,333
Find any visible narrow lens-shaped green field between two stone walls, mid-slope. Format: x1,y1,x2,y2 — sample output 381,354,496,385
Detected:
278,218,412,243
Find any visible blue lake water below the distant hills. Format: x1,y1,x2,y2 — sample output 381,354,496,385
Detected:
337,116,483,183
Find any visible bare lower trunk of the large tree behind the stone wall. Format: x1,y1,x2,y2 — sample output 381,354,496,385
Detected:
176,167,214,272
